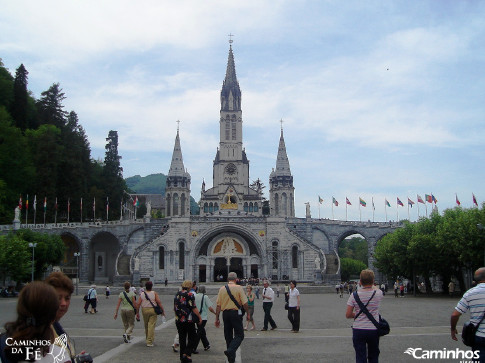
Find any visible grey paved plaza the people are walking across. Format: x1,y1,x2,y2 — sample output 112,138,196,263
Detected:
0,287,468,363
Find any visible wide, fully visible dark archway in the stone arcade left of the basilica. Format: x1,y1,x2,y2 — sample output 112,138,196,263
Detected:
88,231,120,283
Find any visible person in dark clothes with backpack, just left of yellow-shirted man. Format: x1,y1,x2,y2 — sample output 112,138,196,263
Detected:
173,280,202,363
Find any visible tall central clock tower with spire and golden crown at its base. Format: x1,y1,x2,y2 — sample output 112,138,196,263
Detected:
200,45,262,215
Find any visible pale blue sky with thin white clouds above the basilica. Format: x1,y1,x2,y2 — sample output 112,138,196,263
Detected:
0,0,485,221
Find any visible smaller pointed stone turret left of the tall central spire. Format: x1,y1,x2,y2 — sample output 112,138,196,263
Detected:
165,128,190,217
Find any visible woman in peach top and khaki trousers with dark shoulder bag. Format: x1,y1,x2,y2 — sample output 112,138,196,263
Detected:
136,281,165,347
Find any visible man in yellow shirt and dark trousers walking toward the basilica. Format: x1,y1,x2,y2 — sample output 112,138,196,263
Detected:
215,272,250,363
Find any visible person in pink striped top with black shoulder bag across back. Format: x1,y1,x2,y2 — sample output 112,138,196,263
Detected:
345,269,382,363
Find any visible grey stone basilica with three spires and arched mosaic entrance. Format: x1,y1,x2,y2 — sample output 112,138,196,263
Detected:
129,44,339,282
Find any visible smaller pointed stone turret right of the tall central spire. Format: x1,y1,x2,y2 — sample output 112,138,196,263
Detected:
269,127,295,217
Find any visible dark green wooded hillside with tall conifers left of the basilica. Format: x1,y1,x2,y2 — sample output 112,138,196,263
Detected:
0,59,126,224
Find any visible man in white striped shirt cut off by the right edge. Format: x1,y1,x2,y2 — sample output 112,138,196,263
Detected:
450,267,485,363
